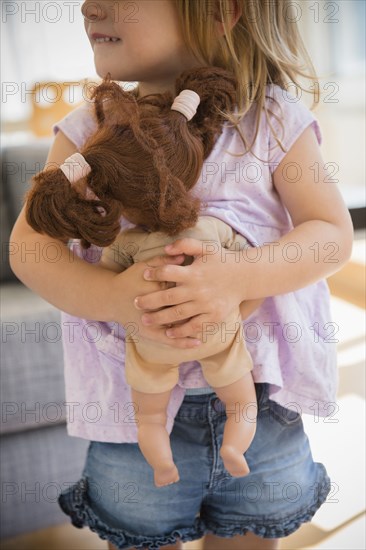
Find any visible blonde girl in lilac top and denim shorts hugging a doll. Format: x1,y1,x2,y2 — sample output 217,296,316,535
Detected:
12,0,353,550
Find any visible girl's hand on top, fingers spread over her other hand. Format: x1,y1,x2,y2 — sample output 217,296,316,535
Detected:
135,238,243,347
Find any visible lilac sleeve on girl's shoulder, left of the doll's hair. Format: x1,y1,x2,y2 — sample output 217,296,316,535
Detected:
52,102,97,149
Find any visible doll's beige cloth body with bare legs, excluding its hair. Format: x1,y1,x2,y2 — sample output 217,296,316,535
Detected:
102,216,256,486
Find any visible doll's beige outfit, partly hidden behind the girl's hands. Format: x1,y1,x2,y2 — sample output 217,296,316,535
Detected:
102,216,252,393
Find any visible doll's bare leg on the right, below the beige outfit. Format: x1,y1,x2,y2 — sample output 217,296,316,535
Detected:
214,372,257,477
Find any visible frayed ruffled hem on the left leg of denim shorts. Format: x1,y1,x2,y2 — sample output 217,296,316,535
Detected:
58,478,205,550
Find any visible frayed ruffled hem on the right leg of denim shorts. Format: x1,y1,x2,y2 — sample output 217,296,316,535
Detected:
203,479,331,539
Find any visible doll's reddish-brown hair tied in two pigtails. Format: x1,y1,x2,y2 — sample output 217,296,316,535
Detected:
26,67,237,247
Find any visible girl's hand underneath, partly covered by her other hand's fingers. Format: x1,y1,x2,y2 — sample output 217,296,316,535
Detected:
110,254,200,349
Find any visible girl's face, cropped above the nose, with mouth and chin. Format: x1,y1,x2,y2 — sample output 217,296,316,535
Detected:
82,0,199,95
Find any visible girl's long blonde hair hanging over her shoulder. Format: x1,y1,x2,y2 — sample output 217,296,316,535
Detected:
175,0,319,156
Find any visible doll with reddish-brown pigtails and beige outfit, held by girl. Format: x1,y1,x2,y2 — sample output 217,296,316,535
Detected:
26,67,260,487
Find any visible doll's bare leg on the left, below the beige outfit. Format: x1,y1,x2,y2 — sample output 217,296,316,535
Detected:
132,388,179,487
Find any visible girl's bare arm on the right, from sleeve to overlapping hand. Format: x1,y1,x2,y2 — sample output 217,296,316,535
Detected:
137,127,353,338
